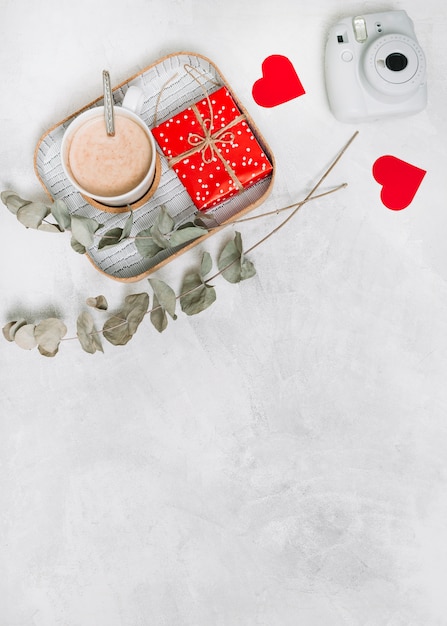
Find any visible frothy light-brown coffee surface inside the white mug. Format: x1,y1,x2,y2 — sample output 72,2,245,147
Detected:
68,115,152,197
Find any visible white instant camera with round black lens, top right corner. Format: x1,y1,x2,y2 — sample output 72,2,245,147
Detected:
326,11,427,123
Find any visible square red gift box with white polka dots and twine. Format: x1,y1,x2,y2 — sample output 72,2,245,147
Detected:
152,87,273,211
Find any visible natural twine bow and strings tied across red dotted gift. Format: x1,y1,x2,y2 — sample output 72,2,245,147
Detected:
169,102,245,191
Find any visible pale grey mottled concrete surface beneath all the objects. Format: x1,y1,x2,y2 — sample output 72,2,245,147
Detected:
0,0,447,626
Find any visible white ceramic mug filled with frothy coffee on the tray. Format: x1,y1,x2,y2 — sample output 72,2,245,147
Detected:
61,86,156,207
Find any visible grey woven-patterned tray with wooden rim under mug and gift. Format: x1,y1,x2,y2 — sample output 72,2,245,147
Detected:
34,52,275,282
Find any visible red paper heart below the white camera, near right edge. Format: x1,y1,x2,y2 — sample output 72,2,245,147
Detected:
373,155,427,211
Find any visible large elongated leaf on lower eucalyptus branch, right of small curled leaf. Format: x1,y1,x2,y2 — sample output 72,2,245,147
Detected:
103,293,149,346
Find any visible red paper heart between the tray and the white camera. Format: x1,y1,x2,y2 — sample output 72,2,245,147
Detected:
252,54,306,107
